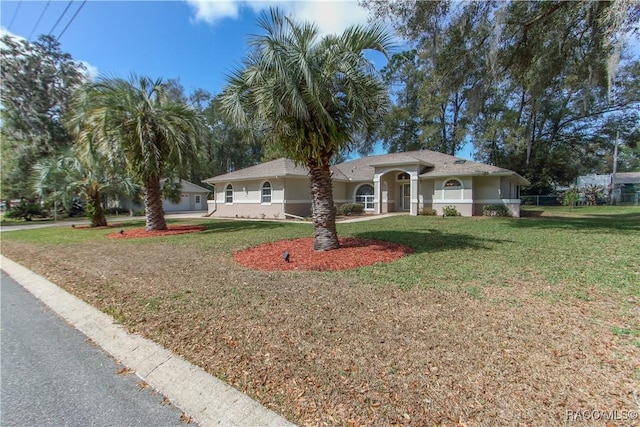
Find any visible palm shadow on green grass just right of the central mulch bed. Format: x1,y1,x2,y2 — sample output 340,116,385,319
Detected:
353,228,511,253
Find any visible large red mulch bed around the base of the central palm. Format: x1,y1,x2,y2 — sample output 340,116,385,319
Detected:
233,237,413,271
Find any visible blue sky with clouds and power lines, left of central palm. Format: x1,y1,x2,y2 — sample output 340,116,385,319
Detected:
0,0,376,94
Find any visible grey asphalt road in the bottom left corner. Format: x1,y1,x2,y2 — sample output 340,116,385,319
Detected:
0,271,186,427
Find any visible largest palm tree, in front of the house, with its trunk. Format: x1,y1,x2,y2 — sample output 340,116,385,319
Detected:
221,9,390,250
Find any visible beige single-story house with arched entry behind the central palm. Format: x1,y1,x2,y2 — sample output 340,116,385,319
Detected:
204,150,529,218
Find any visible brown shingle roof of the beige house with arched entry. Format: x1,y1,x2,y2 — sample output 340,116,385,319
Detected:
204,150,529,185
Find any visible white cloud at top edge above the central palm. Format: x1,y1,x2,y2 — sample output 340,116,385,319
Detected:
187,0,368,34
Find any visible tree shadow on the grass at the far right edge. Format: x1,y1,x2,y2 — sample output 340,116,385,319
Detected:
509,213,640,234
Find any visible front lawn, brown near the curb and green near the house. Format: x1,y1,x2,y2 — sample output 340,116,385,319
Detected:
1,208,640,426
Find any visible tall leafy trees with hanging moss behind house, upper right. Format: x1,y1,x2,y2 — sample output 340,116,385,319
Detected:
361,0,640,194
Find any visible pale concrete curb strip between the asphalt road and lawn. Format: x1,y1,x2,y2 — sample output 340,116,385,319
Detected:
0,255,294,426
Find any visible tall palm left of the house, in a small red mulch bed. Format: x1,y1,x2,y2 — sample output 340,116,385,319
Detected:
72,76,204,231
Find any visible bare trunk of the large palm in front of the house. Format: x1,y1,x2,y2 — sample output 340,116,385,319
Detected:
307,160,340,251
